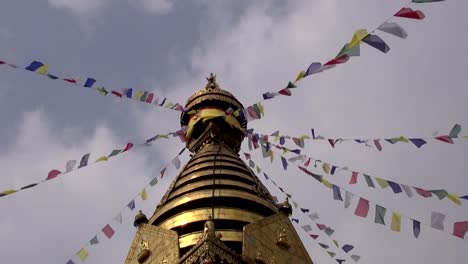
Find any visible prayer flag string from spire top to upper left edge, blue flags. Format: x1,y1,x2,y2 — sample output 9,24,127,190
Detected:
0,58,184,112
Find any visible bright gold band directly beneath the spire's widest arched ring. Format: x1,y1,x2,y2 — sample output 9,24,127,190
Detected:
159,208,263,229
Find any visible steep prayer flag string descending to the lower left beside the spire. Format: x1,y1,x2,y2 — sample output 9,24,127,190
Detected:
67,148,185,263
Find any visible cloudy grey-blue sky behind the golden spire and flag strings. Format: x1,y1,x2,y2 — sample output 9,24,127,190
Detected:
0,0,468,264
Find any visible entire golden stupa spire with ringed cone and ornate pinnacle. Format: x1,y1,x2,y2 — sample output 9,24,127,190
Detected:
125,75,313,264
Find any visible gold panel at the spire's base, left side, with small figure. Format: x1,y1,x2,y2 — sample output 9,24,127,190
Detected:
125,224,179,264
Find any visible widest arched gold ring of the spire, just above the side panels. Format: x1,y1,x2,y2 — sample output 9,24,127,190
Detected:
149,190,278,223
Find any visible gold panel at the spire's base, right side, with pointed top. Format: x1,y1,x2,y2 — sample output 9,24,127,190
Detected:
242,213,313,264
